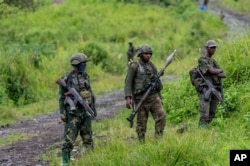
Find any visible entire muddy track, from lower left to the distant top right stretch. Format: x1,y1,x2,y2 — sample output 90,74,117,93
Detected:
0,0,250,166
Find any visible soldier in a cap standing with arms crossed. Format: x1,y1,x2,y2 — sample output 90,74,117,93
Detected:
198,40,226,127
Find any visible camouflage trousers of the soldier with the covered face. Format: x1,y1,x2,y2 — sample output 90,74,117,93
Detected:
62,113,94,152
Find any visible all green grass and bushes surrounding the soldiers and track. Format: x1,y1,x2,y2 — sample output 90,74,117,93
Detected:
0,0,250,165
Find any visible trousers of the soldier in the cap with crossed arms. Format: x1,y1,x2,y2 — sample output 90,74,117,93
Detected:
199,93,219,126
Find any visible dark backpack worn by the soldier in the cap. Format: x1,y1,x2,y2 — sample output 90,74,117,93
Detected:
189,67,204,92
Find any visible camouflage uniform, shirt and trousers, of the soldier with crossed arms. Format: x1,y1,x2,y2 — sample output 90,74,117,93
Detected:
198,57,224,126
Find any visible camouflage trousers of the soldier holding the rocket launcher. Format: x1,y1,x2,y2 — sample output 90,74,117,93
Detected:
136,96,166,140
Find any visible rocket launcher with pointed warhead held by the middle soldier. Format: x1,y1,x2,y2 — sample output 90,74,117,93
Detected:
127,50,176,128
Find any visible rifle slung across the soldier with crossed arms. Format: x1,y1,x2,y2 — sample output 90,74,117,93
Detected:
198,69,227,111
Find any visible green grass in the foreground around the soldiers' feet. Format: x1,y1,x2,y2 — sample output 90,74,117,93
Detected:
43,110,250,166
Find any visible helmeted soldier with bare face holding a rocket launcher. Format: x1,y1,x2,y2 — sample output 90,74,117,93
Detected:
124,44,166,143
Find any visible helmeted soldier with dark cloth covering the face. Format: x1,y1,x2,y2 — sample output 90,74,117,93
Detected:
59,53,97,166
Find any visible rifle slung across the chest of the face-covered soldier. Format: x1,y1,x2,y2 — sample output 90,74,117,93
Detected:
56,78,95,119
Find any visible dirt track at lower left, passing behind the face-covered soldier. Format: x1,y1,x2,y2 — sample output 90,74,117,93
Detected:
0,87,127,166
